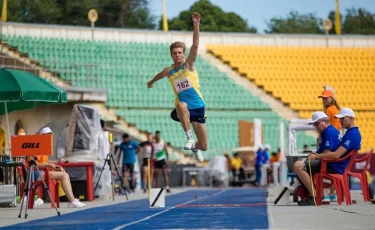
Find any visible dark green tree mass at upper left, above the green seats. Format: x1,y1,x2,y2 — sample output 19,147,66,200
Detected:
0,0,155,29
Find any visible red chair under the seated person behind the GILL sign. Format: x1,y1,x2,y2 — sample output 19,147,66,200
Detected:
17,166,60,209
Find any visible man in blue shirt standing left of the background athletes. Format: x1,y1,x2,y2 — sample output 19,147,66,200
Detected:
119,133,139,191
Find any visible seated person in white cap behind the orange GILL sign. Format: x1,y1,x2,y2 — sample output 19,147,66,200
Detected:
34,127,86,208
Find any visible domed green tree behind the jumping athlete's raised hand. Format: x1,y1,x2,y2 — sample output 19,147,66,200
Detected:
159,0,257,33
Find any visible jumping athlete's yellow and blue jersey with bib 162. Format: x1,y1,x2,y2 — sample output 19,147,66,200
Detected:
169,64,205,109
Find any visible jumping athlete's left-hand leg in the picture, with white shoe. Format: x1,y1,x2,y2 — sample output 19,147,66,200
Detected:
176,102,194,150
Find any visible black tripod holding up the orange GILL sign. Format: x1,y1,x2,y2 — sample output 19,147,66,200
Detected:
18,160,60,219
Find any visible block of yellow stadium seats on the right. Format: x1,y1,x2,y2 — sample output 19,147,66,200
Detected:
206,44,375,151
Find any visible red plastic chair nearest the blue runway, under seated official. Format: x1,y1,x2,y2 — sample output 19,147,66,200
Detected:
314,151,358,205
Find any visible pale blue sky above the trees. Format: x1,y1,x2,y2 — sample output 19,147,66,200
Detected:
149,0,375,33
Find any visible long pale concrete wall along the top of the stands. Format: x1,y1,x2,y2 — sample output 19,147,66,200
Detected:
3,23,375,49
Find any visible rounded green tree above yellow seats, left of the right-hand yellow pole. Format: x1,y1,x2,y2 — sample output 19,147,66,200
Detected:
264,11,323,34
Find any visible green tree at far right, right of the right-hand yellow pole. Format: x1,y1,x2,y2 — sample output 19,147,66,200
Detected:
342,8,375,34
